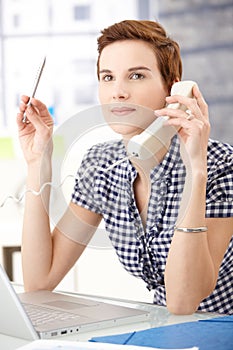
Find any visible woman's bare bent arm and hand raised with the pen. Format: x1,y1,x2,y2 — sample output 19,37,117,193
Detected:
17,96,101,290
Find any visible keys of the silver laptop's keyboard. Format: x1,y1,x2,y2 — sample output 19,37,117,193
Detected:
23,304,79,326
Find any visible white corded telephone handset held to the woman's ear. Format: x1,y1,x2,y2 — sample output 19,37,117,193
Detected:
127,80,196,159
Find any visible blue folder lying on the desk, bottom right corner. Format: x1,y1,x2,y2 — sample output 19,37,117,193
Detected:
91,316,233,350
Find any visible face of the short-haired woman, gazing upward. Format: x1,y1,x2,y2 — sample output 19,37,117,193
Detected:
99,40,168,137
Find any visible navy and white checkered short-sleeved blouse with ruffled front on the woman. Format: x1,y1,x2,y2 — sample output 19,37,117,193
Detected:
72,137,233,314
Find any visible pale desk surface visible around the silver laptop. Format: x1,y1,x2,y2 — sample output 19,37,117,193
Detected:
0,285,216,350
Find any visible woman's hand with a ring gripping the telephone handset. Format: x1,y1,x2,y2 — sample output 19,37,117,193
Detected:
155,85,210,169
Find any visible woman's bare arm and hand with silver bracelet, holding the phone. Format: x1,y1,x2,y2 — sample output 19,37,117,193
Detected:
156,86,233,314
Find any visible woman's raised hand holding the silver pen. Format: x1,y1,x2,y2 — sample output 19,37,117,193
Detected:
17,95,53,164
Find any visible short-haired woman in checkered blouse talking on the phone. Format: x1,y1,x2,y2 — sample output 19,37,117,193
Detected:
17,20,233,314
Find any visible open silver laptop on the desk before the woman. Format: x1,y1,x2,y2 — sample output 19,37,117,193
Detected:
0,265,149,340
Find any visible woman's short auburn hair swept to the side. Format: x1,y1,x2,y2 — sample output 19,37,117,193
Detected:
97,20,182,91
